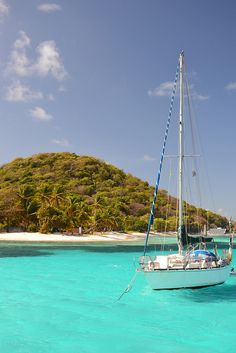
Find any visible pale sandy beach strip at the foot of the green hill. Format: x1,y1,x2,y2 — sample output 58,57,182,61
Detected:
0,232,144,243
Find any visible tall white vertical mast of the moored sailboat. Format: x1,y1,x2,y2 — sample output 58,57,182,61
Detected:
178,51,184,253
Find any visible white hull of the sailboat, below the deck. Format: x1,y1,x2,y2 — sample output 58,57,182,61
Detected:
144,265,230,289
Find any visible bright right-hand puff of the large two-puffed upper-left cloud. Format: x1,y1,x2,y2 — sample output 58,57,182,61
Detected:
33,40,67,80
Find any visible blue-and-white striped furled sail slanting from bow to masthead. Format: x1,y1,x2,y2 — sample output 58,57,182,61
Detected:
143,62,179,256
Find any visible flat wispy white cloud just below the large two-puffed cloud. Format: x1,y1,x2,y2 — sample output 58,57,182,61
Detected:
5,81,43,102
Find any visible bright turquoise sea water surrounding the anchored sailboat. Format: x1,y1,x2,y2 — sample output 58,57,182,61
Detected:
0,239,236,353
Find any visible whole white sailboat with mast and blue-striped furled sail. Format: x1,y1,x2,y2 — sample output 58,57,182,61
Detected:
139,52,233,290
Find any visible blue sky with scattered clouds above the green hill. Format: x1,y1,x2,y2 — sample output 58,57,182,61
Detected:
0,0,236,219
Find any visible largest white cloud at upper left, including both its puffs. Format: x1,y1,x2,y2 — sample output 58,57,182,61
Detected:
7,31,67,81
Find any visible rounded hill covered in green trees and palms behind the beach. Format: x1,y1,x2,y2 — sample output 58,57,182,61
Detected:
0,152,230,232
